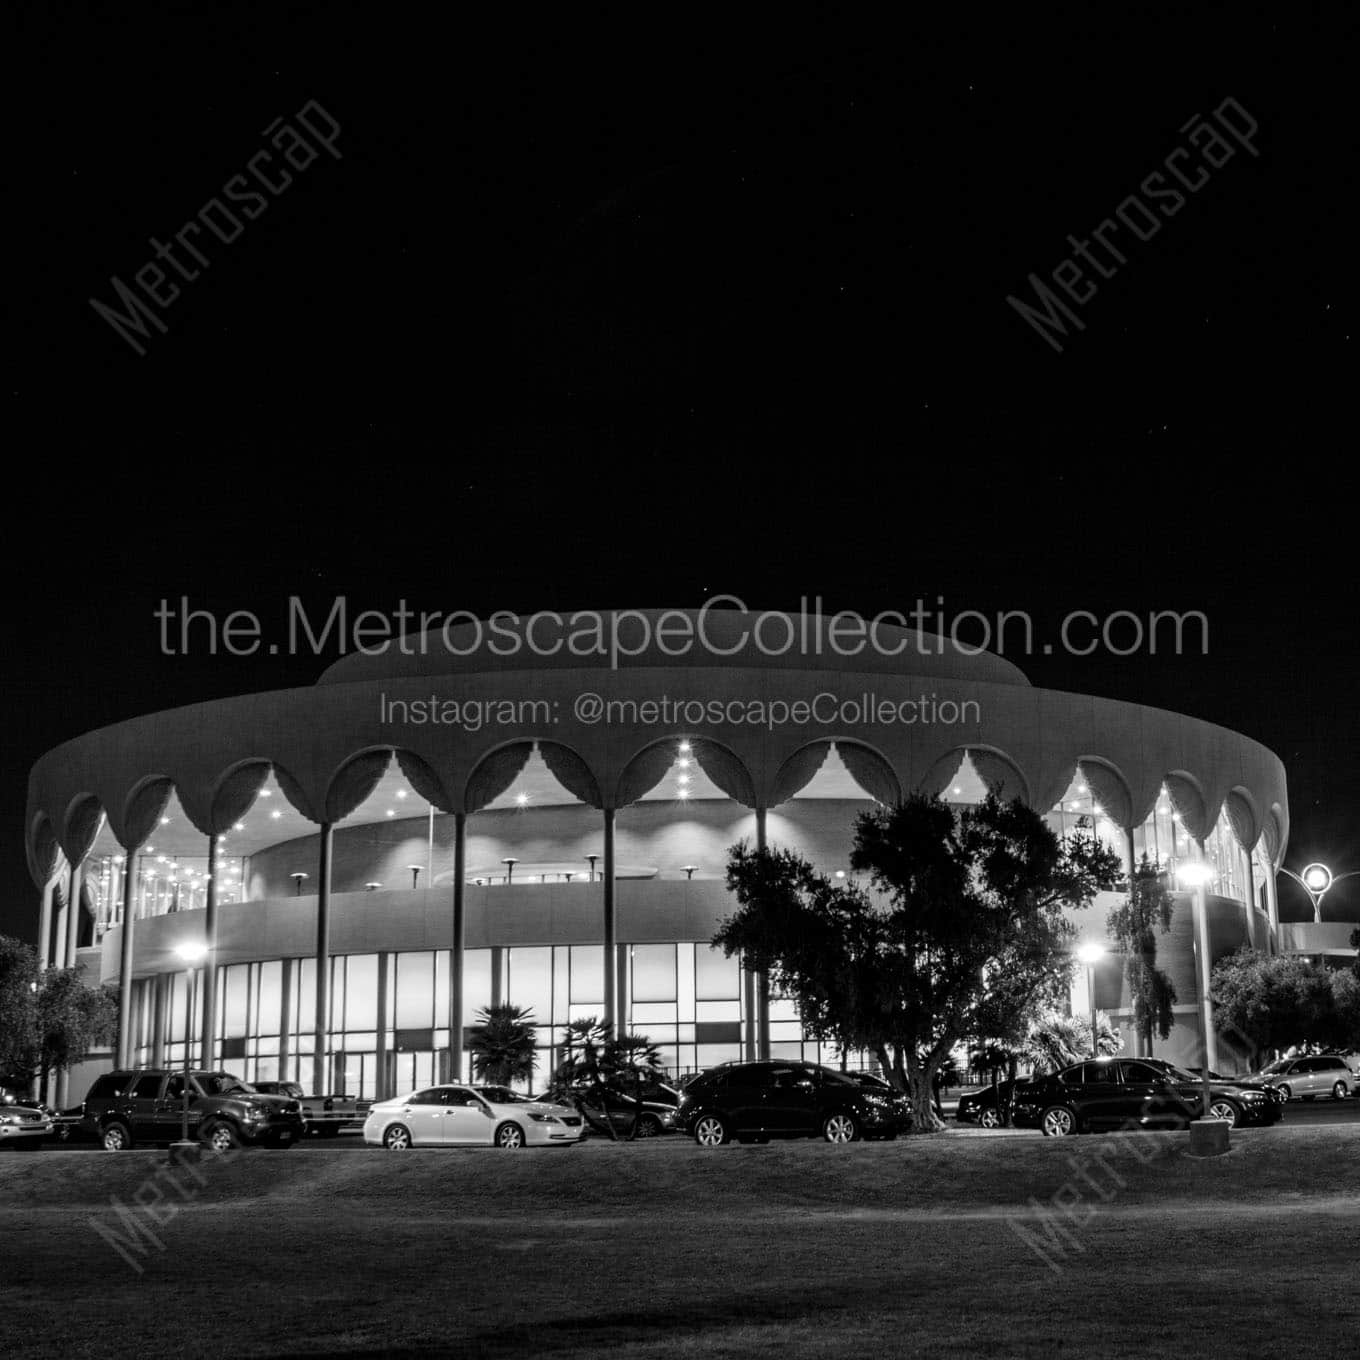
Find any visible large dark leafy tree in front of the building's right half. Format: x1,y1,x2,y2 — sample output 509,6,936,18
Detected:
714,797,1119,1132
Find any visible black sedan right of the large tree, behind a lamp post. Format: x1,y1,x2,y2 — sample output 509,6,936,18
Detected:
1016,1058,1284,1138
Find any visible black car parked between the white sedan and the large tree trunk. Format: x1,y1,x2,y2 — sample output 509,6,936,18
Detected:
676,1062,911,1148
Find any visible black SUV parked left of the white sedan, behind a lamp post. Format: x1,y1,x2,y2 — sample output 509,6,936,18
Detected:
80,1068,306,1152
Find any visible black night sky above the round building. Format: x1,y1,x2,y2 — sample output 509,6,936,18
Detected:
0,5,1360,938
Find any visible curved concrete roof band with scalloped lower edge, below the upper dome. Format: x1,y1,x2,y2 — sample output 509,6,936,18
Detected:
26,647,1289,884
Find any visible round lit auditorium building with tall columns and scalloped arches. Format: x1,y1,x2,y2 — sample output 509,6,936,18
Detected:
26,611,1294,1099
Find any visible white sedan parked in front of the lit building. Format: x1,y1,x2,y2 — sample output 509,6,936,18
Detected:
363,1087,585,1152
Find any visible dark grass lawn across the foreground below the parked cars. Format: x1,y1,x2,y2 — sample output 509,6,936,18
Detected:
0,1126,1360,1360
